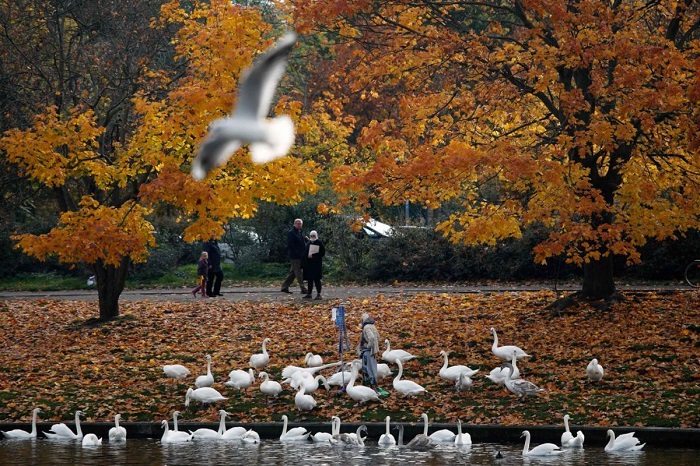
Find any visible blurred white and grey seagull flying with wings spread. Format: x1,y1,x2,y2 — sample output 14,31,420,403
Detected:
192,31,296,180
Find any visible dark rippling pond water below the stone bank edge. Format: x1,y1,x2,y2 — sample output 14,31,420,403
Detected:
0,439,700,466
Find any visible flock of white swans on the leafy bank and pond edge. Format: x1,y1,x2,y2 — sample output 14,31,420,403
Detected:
3,328,645,456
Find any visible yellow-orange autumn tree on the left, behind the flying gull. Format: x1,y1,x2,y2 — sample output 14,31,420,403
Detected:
0,0,317,320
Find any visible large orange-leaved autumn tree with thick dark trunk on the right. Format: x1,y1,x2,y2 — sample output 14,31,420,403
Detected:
291,0,700,298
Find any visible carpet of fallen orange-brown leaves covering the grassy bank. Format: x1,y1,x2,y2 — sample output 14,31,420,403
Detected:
0,291,700,427
